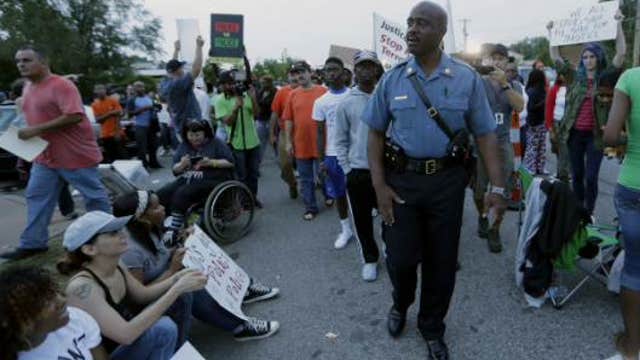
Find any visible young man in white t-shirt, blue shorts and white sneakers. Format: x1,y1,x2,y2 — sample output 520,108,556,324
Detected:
312,57,353,249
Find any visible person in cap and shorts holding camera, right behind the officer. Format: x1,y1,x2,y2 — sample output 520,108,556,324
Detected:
473,44,524,253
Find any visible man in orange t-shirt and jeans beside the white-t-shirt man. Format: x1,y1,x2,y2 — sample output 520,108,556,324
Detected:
282,61,327,220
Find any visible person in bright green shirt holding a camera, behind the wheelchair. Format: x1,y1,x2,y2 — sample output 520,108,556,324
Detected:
214,70,262,208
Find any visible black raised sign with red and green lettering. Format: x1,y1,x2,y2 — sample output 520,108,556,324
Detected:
209,14,244,63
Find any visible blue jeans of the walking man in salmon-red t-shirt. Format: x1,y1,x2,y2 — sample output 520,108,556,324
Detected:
20,164,111,249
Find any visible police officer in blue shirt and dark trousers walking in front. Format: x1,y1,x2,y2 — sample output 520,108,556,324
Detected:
363,1,506,359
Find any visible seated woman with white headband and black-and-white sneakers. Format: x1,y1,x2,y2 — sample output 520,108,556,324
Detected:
113,191,279,341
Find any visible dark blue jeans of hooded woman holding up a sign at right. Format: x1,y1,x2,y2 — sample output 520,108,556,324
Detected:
567,129,603,213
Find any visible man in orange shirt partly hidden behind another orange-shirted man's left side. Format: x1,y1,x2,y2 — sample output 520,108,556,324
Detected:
270,69,298,199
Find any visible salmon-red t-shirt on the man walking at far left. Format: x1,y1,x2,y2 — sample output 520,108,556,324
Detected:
23,75,102,170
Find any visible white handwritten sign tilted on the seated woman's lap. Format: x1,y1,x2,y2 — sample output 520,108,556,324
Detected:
182,226,250,319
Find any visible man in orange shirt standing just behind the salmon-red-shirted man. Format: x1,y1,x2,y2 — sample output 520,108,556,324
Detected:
91,84,124,163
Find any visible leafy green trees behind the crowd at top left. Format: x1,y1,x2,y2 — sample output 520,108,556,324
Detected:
0,0,160,91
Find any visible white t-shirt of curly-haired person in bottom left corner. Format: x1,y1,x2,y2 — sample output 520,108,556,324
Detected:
18,306,106,360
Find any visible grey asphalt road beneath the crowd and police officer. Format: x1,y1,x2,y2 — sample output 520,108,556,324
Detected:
0,148,622,360
